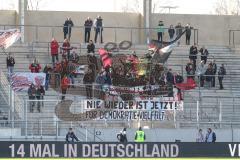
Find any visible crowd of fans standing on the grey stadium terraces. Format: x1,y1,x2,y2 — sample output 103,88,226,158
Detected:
3,16,226,112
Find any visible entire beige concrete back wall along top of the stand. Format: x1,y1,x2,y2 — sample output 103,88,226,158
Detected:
0,11,240,45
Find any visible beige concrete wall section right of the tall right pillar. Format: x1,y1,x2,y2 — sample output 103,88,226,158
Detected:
151,14,240,45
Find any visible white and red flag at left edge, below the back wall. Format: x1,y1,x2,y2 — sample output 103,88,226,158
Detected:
0,29,21,49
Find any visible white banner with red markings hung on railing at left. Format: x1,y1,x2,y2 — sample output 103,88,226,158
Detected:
11,72,46,91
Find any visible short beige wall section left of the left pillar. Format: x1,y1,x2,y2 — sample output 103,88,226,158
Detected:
0,10,16,29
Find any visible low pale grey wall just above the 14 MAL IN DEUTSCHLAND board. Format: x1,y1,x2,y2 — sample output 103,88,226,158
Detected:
60,128,240,142
